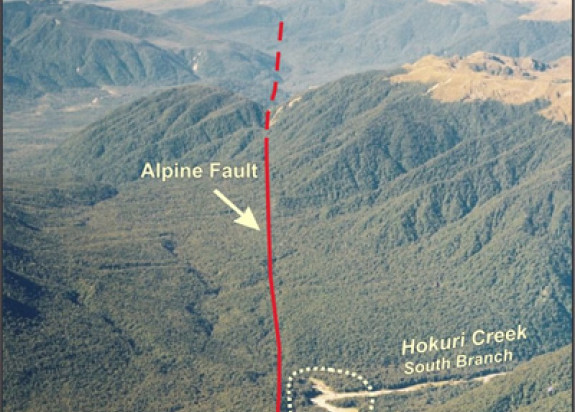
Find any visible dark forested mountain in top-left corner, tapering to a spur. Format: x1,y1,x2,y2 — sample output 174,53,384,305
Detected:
3,2,197,94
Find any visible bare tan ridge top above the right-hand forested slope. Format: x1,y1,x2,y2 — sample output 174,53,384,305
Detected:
391,52,573,124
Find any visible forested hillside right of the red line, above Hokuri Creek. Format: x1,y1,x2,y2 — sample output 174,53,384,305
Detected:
266,74,571,381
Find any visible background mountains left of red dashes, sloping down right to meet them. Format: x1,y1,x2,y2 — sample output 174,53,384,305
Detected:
3,1,281,98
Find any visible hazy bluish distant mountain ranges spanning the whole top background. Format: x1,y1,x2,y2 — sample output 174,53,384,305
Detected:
3,0,571,99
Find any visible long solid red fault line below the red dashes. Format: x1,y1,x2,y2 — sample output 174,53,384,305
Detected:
264,137,282,412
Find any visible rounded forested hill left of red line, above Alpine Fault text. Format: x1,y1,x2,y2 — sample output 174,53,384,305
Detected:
49,86,264,184
